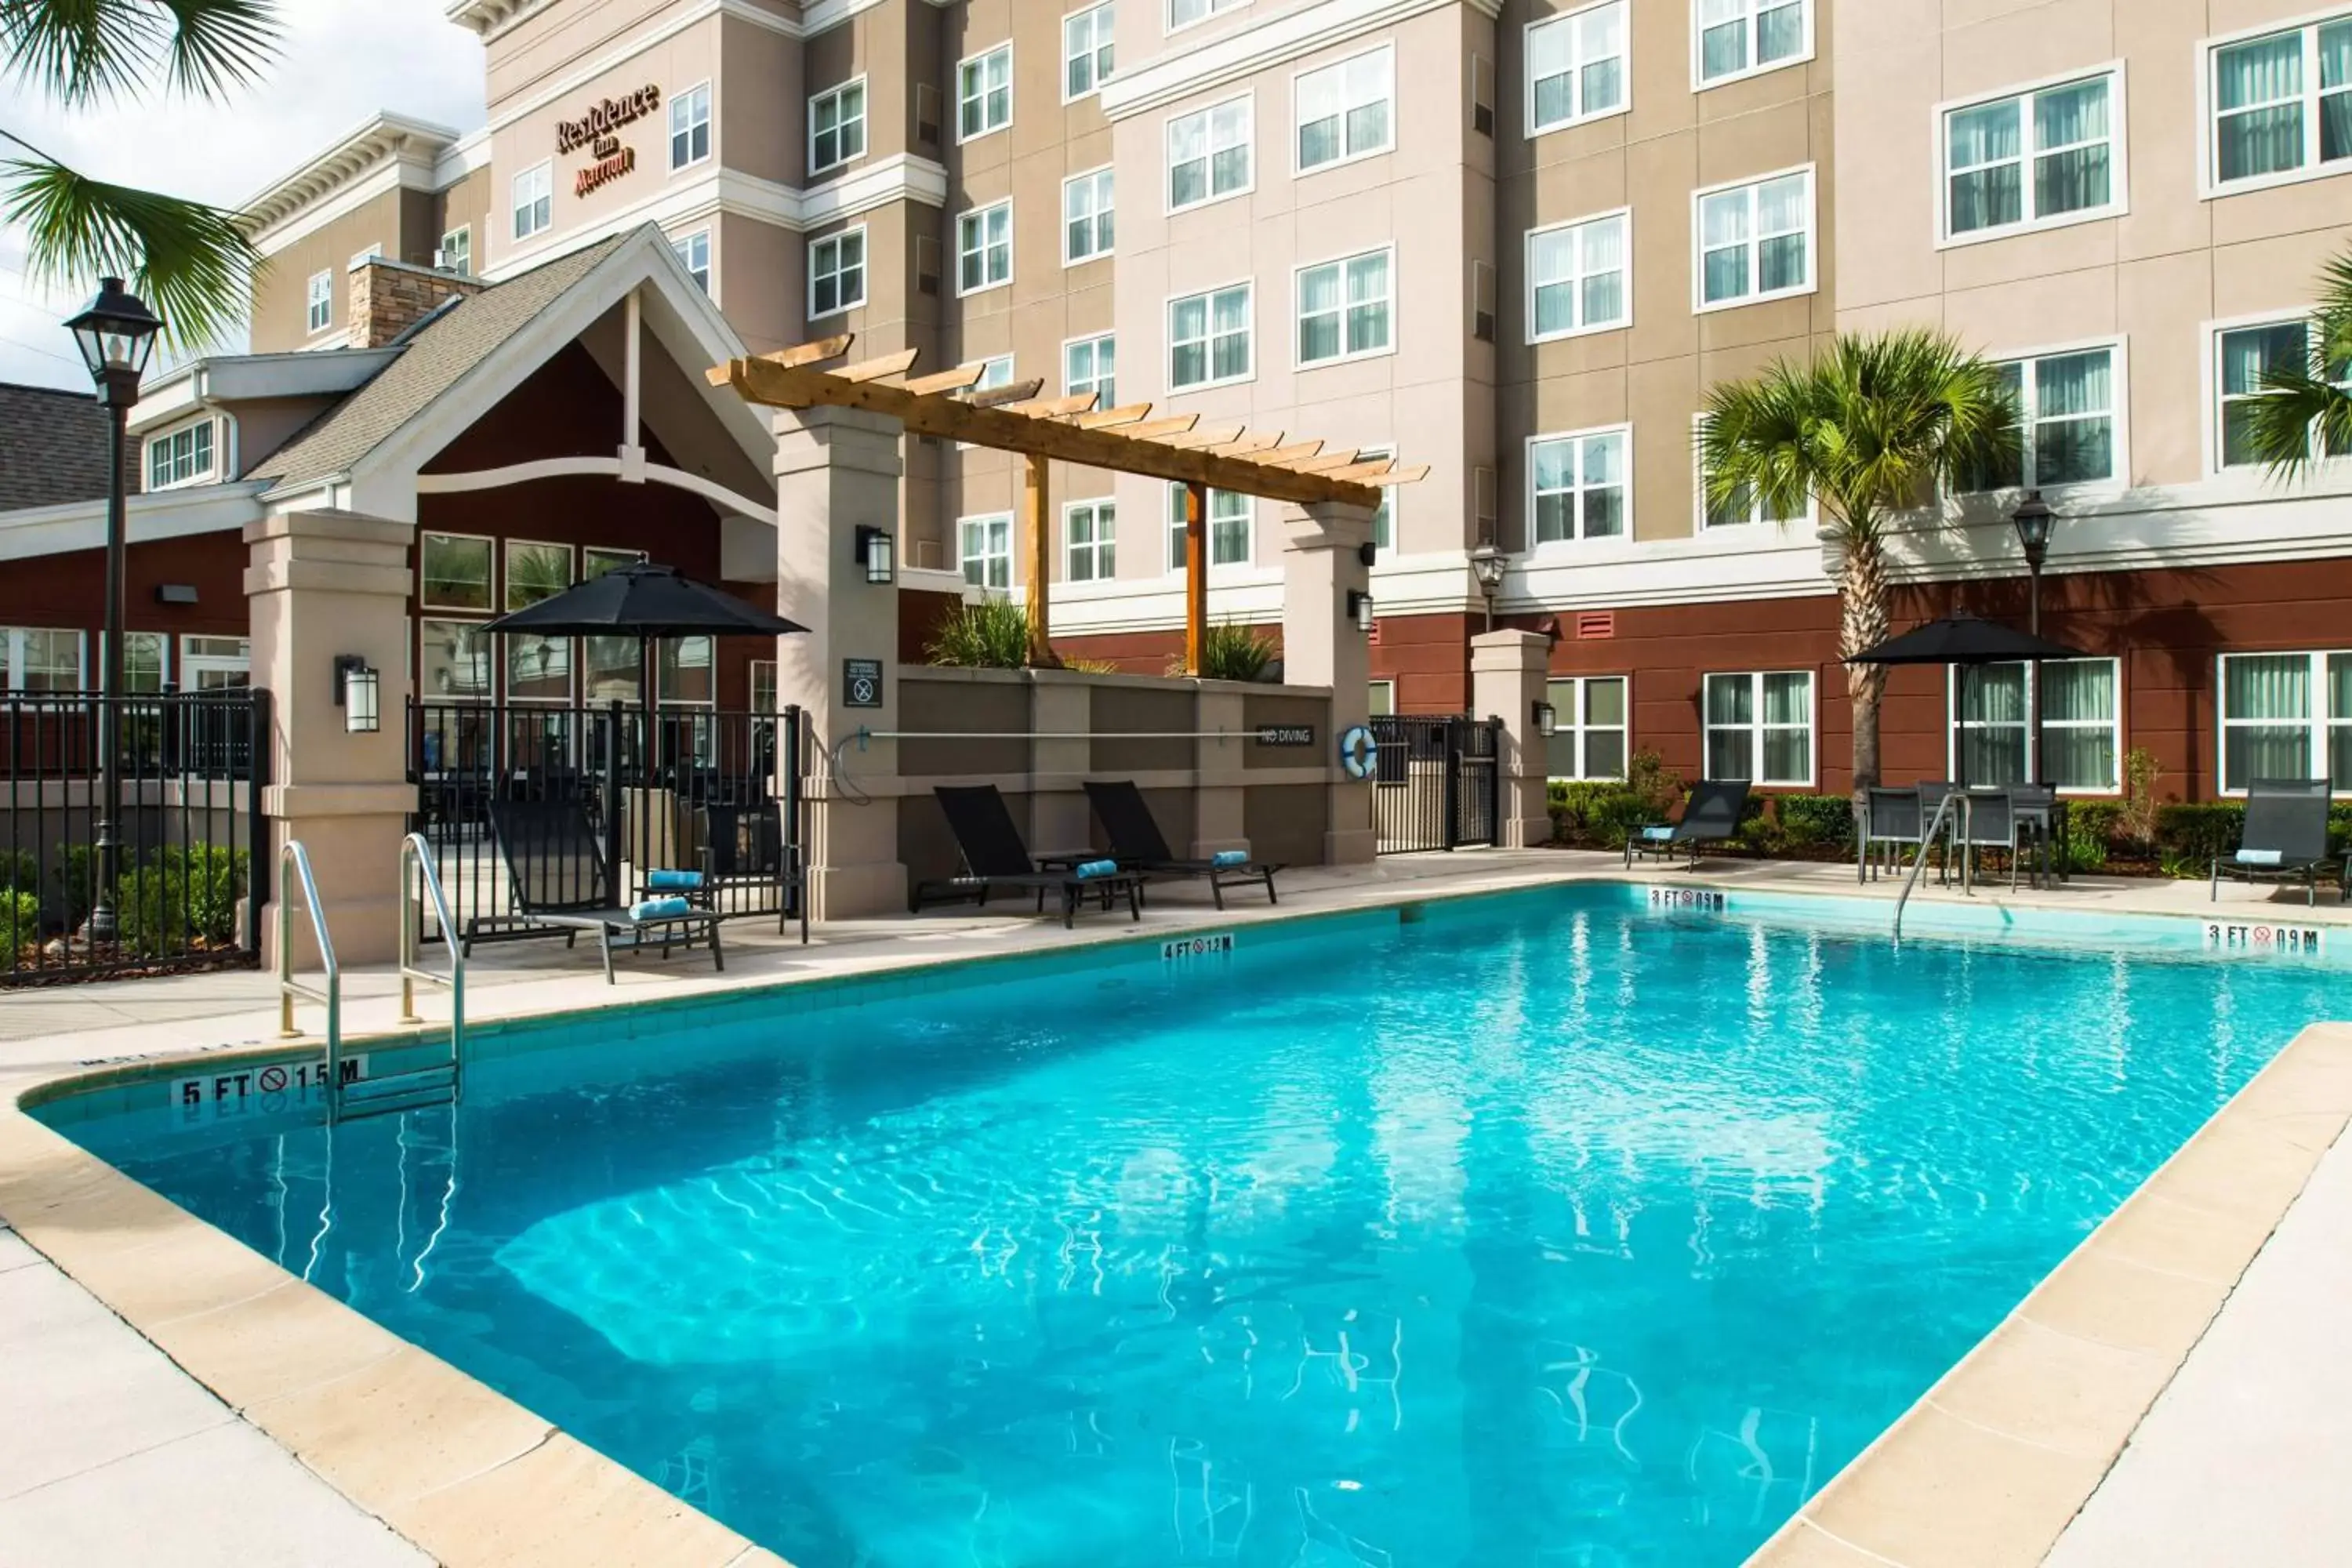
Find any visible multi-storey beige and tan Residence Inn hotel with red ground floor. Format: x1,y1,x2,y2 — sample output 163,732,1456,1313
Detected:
0,0,2352,799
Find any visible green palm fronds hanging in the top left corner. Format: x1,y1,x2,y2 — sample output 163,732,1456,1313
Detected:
0,0,280,350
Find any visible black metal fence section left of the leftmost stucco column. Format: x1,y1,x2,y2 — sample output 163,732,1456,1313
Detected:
0,689,270,985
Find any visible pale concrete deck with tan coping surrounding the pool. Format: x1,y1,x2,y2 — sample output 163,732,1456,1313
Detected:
0,851,2352,1568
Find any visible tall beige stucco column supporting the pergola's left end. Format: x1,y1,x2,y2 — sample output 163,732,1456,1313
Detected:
774,409,906,919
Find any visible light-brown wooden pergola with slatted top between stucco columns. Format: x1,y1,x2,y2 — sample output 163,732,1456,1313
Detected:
708,334,1430,675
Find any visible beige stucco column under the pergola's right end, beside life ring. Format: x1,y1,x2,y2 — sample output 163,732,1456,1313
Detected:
1282,501,1378,865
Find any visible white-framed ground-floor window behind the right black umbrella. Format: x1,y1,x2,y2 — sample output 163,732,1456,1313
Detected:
1945,659,2124,794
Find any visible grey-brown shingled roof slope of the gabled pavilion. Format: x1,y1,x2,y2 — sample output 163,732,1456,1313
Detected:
247,233,630,485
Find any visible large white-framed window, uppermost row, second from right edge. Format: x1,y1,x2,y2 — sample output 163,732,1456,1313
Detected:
1940,66,2129,242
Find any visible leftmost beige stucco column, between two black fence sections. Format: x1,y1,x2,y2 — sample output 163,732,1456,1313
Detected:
245,513,416,968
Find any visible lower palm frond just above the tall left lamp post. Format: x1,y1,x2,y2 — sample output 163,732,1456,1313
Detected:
0,160,261,350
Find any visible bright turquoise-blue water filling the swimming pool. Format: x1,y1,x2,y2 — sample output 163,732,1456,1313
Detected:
54,888,2345,1568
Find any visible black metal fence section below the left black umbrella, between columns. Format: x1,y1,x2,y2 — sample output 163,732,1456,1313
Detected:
407,701,807,942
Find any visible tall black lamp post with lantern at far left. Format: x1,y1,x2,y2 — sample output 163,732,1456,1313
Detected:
66,278,162,945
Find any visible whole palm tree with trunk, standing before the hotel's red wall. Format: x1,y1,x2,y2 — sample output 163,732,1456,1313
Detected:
1700,329,2018,801
